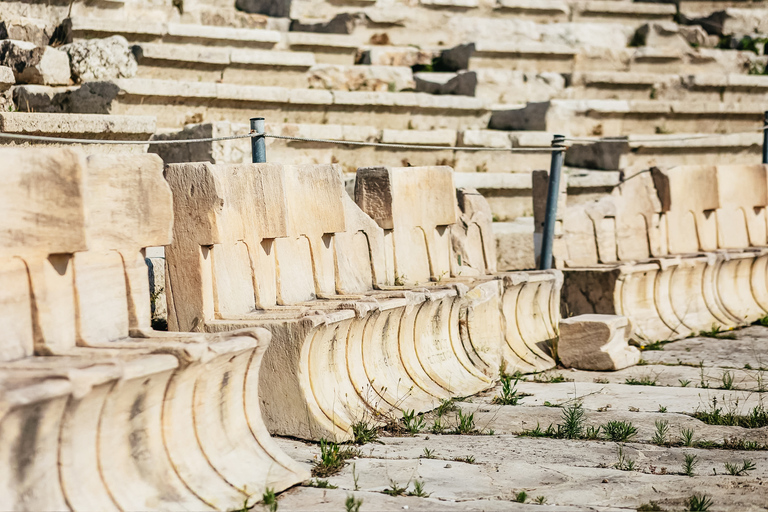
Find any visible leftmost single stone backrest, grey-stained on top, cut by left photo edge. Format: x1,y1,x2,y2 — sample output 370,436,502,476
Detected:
0,148,86,361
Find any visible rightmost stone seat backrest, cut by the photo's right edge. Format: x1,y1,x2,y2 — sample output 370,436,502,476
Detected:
712,165,768,249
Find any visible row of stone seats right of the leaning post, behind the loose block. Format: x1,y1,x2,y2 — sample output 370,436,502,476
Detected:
534,165,768,341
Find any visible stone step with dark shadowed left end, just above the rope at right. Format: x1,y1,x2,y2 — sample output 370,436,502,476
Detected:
489,100,765,137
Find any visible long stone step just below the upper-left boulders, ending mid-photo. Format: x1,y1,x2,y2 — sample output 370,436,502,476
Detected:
14,79,490,130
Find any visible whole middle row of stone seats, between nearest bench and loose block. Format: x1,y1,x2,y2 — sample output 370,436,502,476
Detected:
166,163,562,440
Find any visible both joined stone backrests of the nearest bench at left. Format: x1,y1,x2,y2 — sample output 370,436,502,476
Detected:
1,150,173,358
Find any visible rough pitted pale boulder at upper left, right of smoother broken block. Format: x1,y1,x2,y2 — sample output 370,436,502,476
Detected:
61,36,138,82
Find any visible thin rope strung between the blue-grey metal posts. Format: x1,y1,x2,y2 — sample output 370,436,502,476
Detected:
0,125,768,153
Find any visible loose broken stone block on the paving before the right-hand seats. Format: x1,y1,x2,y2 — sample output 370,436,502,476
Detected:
557,315,640,371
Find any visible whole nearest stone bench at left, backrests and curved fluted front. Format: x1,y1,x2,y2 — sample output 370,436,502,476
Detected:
0,150,307,510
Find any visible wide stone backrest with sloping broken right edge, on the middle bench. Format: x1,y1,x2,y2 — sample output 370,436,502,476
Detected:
166,163,393,330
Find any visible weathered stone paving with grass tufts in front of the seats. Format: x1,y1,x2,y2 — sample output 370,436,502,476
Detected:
270,326,768,512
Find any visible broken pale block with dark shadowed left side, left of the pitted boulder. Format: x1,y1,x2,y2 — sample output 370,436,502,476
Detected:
0,39,70,85
